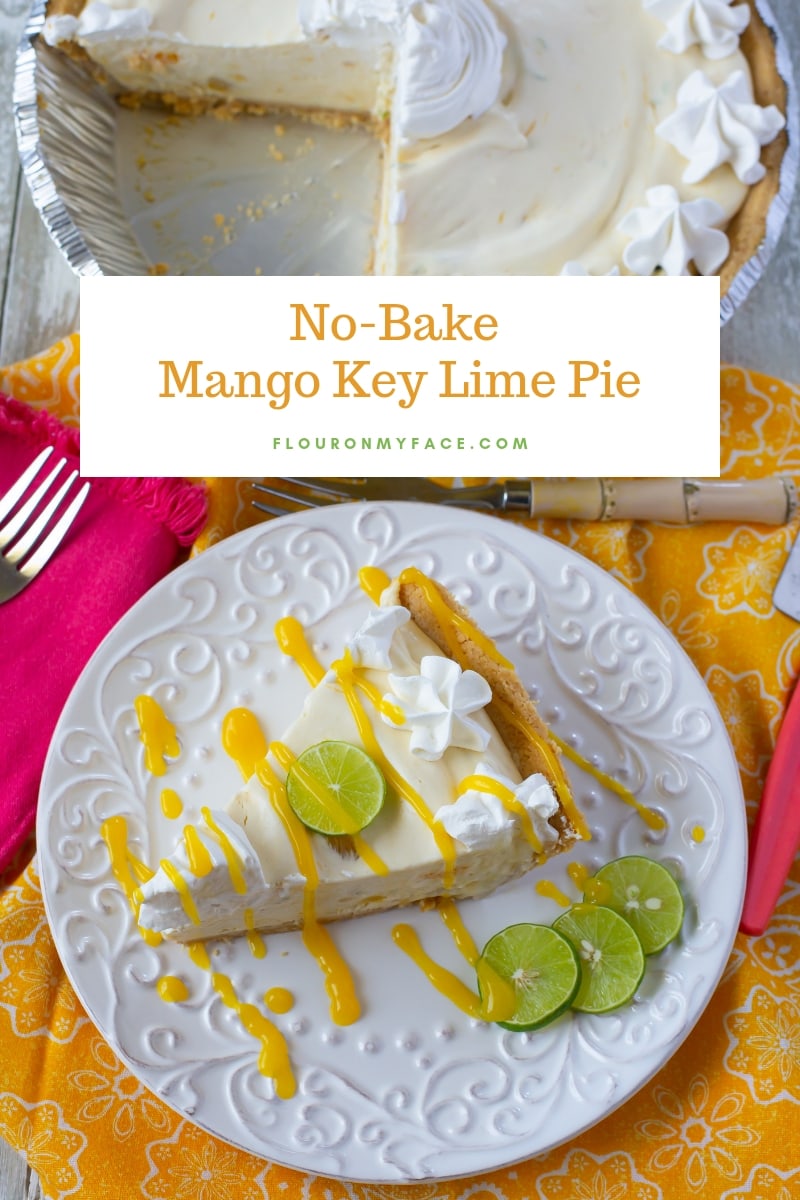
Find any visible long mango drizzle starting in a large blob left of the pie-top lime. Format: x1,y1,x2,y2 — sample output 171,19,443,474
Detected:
222,708,361,1025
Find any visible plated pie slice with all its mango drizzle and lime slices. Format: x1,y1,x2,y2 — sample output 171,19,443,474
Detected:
101,566,682,1099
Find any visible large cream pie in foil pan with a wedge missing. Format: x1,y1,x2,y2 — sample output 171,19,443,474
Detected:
38,0,787,276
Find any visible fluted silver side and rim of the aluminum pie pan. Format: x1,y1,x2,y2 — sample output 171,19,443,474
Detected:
13,0,800,324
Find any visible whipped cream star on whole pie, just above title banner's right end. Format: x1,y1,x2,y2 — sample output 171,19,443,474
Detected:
619,185,729,275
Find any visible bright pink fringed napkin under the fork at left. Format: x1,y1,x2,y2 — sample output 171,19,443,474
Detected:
0,394,206,870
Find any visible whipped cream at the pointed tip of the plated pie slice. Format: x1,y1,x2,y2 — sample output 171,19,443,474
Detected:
139,809,266,932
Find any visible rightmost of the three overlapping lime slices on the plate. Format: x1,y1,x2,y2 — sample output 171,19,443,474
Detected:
584,854,684,954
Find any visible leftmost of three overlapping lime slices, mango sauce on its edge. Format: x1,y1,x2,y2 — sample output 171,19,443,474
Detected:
477,924,581,1030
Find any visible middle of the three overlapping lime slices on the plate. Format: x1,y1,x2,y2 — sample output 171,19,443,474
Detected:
553,904,644,1013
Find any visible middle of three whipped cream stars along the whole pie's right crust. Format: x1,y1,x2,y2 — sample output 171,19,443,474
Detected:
656,71,786,184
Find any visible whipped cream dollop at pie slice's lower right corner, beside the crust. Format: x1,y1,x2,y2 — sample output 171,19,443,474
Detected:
434,762,558,850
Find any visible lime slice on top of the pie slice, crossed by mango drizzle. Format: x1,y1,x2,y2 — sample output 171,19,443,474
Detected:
287,742,386,834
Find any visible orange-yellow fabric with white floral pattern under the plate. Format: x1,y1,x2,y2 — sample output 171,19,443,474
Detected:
0,340,800,1200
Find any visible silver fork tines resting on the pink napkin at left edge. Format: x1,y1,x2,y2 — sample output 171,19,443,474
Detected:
0,446,89,604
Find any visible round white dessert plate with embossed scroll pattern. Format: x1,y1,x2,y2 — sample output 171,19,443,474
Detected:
37,504,746,1183
